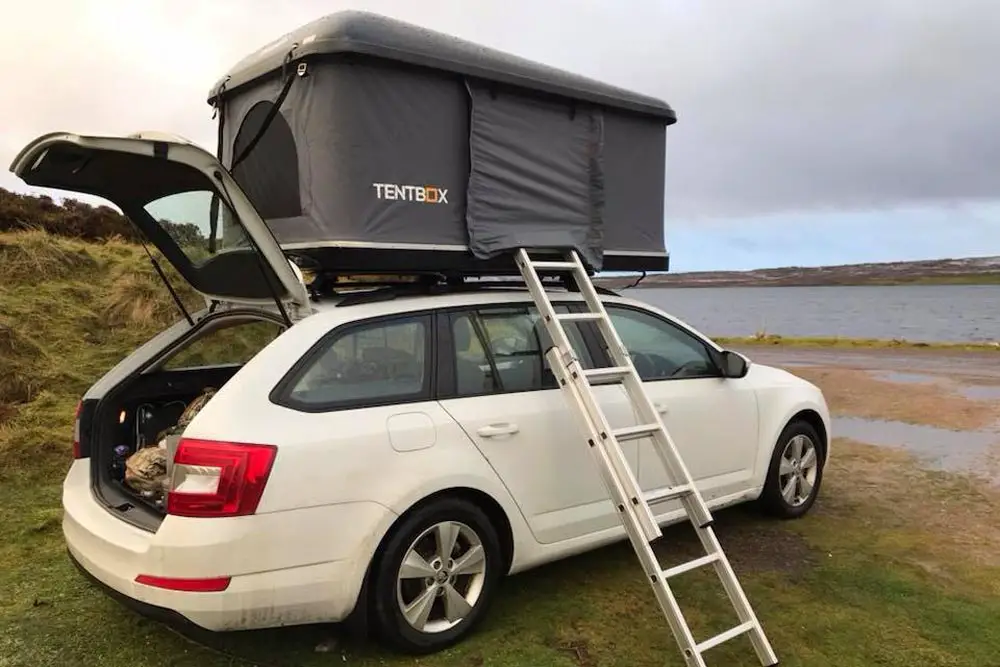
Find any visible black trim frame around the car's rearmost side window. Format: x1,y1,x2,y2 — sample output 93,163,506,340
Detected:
268,310,438,414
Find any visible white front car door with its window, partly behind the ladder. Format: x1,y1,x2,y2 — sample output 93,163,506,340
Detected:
607,304,758,515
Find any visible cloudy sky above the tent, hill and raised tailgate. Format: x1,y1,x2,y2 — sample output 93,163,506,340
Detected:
0,0,1000,270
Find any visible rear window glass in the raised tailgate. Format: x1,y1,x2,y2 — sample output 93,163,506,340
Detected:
143,189,250,266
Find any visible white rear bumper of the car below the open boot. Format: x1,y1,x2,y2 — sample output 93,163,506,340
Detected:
63,460,392,631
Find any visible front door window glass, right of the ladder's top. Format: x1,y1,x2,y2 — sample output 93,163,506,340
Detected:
607,306,719,380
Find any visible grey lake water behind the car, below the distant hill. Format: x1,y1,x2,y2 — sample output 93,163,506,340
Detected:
623,285,1000,342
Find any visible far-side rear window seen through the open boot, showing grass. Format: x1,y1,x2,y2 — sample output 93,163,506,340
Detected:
163,320,285,370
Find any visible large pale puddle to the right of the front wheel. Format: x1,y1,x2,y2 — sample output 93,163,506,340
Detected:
833,417,1000,479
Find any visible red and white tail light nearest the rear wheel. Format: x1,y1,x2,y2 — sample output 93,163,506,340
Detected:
167,438,278,518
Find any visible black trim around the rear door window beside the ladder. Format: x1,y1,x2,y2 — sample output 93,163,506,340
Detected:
436,300,596,401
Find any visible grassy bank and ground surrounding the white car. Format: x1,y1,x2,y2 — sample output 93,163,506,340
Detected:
0,232,1000,667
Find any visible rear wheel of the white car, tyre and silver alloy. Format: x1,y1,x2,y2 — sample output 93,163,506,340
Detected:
372,498,503,655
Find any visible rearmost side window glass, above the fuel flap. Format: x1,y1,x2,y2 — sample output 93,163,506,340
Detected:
288,316,431,409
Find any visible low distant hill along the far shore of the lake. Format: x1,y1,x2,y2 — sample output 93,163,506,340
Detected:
596,256,1000,289
